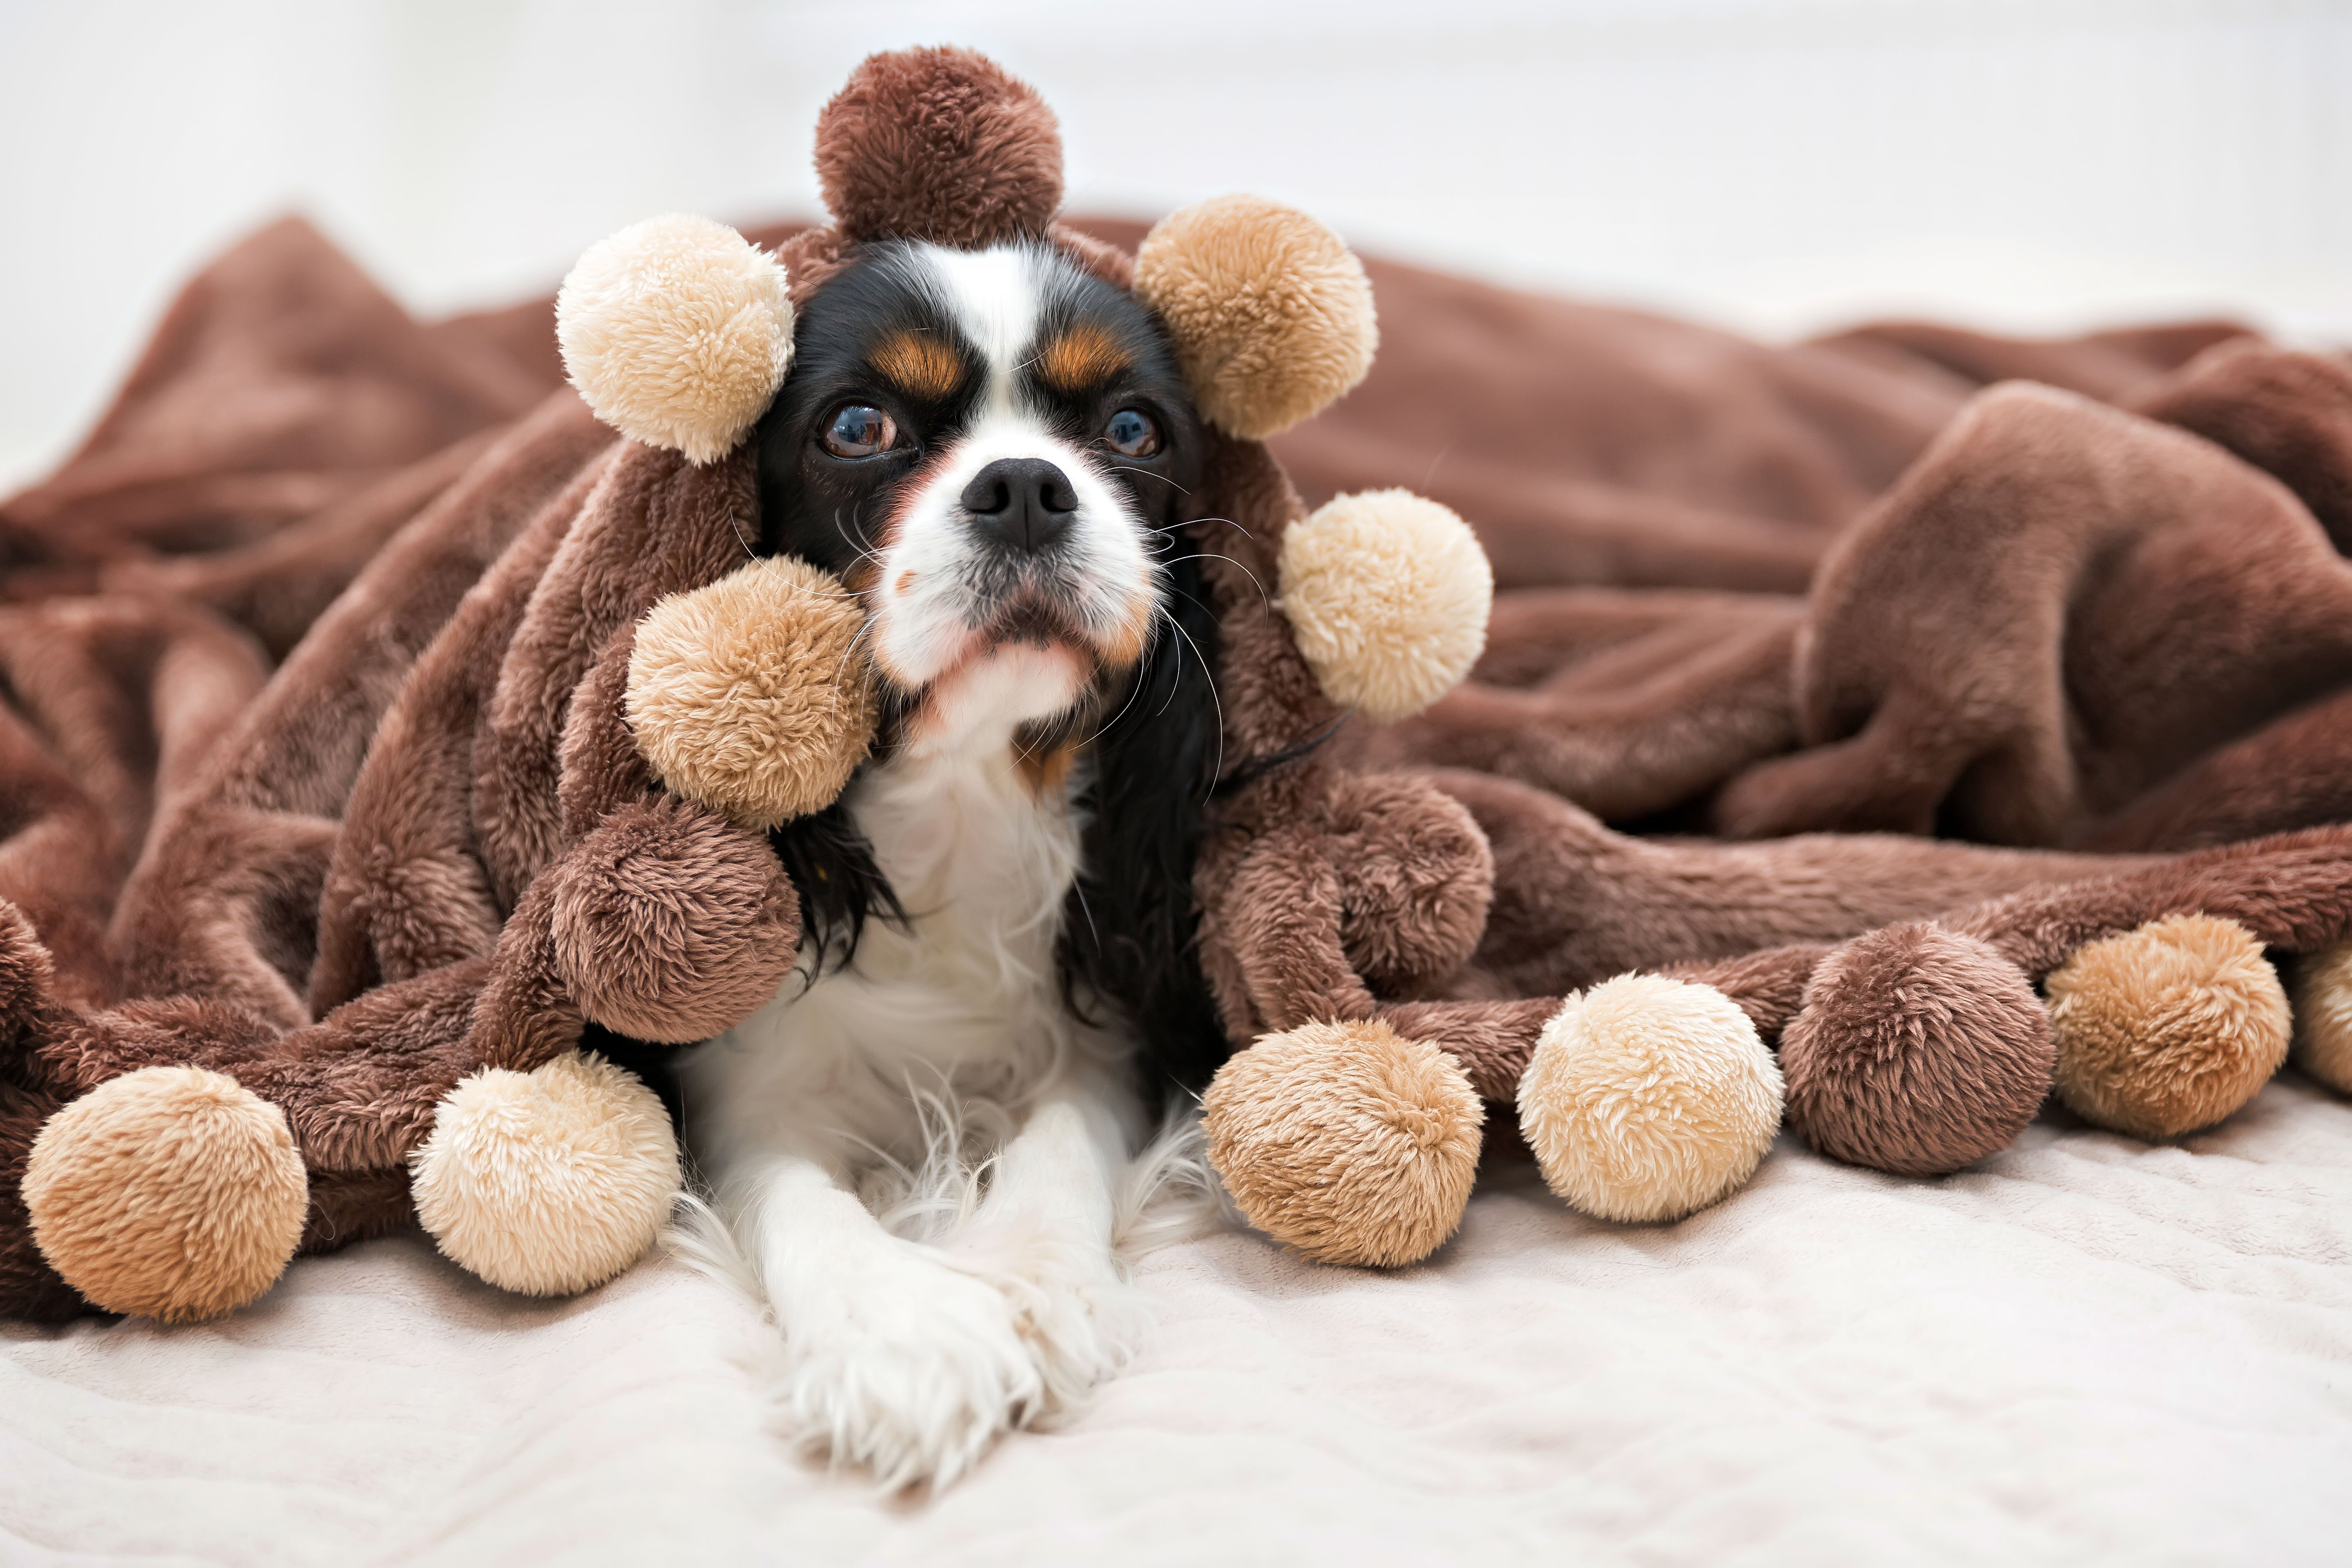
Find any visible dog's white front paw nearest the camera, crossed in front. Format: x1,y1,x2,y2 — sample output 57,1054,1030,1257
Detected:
776,1258,1047,1490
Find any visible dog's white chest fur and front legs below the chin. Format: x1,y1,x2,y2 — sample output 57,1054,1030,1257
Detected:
682,682,1166,1486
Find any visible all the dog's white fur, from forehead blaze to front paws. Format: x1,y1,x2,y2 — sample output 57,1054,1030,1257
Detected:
677,249,1207,1488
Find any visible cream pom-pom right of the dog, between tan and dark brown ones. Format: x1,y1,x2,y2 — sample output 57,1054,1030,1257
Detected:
1519,976,1780,1220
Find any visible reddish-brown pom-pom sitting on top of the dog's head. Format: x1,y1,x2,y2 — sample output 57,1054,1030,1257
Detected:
816,49,1061,249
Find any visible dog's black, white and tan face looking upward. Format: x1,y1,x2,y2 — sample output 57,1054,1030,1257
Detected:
757,242,1200,750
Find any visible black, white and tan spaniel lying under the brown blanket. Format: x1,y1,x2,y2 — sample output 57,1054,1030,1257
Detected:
680,242,1223,1488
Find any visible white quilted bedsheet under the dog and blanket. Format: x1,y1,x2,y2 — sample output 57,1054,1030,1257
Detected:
0,1074,2352,1568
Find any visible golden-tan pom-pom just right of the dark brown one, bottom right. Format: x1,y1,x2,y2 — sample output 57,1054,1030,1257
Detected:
2042,915,2293,1138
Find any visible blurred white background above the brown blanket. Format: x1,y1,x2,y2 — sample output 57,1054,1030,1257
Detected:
0,0,2352,482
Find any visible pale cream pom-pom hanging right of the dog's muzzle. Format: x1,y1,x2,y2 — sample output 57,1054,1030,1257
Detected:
1279,489,1494,724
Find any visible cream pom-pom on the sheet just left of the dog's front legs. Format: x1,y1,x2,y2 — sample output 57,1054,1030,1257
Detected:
409,1053,677,1295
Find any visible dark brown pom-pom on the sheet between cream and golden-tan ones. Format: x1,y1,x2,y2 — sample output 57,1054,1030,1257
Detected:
1780,922,2051,1176
